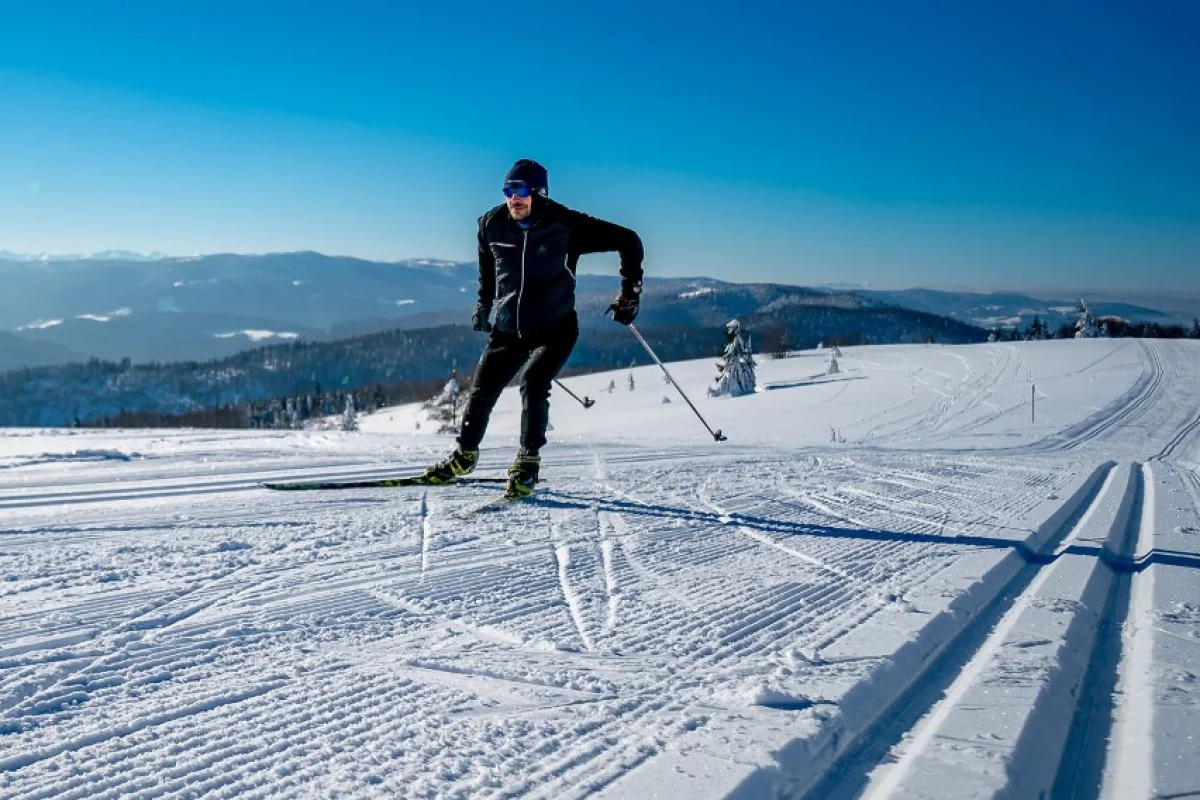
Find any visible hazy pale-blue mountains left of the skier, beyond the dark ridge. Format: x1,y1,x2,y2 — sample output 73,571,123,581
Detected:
0,253,478,362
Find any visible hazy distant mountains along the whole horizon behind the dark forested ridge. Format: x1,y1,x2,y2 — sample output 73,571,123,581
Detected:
0,251,1200,369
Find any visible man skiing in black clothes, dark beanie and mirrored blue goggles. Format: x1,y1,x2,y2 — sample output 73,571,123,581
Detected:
425,158,642,498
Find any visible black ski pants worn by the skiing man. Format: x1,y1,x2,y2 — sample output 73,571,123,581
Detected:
458,312,580,451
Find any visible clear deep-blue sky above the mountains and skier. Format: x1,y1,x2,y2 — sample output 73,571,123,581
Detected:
0,0,1200,291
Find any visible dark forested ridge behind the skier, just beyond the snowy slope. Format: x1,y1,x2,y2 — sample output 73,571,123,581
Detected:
0,281,986,426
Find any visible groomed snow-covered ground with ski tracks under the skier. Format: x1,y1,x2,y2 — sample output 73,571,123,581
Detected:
0,339,1200,800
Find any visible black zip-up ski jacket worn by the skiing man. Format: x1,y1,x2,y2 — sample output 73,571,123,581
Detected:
479,197,642,336
